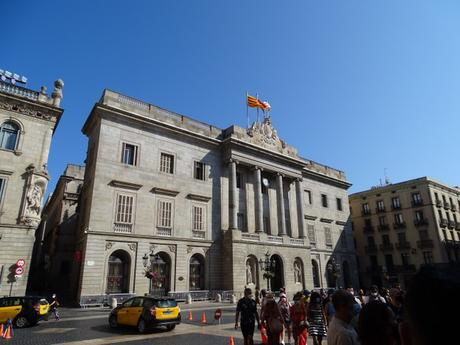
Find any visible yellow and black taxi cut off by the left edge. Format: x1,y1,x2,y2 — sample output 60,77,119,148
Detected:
0,296,50,328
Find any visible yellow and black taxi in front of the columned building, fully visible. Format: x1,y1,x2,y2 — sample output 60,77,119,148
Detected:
109,296,181,333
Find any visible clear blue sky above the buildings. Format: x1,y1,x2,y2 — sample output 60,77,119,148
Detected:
0,0,460,192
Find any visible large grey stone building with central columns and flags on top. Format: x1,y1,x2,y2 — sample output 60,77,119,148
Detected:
75,90,357,296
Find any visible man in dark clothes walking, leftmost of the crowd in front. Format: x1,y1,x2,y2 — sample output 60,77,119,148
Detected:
235,288,260,345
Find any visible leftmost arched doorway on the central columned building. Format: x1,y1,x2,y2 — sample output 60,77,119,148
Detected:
106,250,131,293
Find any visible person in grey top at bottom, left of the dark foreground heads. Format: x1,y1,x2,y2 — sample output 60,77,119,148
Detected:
327,290,359,345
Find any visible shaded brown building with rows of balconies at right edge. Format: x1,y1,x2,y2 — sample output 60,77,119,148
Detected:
350,177,460,287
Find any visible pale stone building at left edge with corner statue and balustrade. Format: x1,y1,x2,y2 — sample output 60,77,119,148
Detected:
0,81,63,296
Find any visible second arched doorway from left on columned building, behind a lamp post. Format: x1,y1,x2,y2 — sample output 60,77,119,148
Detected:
150,252,171,297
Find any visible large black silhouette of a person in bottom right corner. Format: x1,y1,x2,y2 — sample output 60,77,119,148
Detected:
399,265,460,345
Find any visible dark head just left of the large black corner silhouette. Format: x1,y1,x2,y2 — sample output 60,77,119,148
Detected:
358,301,399,345
